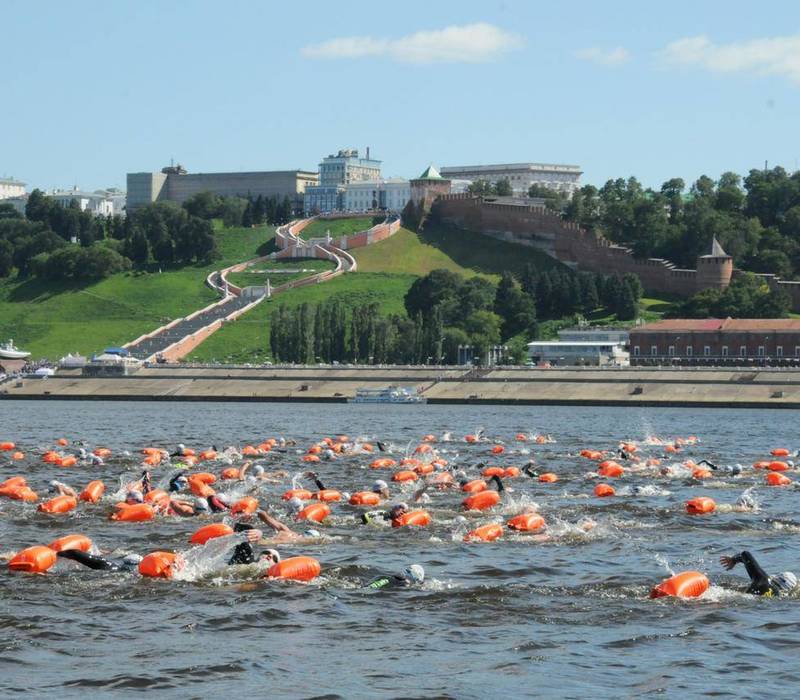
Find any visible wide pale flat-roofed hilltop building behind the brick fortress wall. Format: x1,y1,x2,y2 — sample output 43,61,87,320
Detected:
441,163,583,195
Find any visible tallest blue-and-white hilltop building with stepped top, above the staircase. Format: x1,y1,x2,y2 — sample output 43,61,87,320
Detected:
303,148,381,214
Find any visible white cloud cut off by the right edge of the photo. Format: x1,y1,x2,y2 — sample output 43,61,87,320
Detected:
661,34,800,83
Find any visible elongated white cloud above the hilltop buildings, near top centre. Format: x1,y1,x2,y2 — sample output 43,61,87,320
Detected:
301,22,523,63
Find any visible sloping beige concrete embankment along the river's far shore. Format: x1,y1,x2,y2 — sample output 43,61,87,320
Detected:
0,365,800,408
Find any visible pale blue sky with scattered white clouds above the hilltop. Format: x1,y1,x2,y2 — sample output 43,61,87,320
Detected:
0,0,800,190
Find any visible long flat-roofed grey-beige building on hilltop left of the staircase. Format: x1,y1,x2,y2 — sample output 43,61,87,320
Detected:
127,165,319,212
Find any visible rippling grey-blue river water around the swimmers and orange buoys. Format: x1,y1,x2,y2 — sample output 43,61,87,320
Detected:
0,401,800,698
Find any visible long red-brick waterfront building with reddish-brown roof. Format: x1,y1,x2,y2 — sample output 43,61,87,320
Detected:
630,318,800,365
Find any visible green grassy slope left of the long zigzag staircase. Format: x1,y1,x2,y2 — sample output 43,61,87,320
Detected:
0,227,274,359
